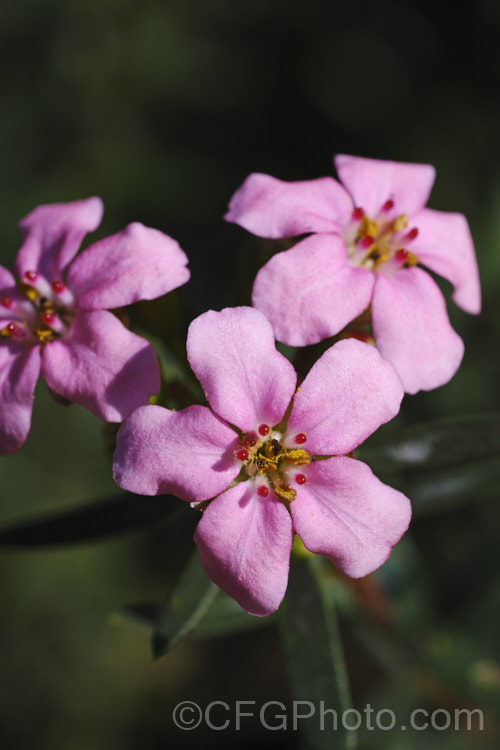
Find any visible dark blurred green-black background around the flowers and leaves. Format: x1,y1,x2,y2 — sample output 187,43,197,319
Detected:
0,0,500,750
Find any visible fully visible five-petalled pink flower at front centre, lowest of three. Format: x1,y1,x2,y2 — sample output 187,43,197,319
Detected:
114,307,411,616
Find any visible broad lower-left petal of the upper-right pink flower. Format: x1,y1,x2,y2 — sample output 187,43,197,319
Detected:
252,234,375,346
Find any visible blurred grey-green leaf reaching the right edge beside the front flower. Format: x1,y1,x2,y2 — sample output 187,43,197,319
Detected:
355,414,500,475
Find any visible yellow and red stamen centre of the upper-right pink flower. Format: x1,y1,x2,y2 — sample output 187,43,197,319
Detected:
344,200,418,272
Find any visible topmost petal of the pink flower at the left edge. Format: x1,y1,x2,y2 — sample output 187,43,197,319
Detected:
14,198,103,281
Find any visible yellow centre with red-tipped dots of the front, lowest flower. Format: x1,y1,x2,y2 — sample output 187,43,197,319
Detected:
234,424,312,502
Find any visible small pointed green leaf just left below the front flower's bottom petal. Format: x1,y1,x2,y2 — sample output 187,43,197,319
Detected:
151,549,218,659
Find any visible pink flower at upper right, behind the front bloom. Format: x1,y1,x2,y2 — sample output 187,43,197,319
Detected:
225,155,481,393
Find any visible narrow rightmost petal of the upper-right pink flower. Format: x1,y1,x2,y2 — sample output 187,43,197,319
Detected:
411,208,481,313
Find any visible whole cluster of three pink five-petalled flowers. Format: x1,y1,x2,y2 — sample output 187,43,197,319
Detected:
0,156,481,616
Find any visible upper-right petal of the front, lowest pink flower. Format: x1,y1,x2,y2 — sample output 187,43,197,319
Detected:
287,339,404,455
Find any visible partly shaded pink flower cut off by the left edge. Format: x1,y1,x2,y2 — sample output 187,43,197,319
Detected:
0,198,189,453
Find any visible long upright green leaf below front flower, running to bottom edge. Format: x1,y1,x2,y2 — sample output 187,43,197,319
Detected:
279,557,356,750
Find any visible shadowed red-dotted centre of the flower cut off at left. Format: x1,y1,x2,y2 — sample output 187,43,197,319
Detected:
0,271,74,344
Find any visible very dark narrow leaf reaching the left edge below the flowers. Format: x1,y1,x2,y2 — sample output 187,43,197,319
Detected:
0,493,184,549
